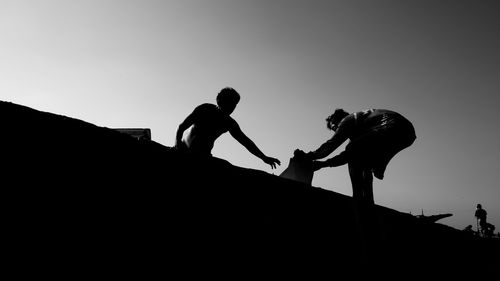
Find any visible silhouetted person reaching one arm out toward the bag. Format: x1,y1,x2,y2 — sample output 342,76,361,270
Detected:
175,87,281,169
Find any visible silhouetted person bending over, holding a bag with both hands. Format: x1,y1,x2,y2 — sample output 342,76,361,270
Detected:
307,109,416,204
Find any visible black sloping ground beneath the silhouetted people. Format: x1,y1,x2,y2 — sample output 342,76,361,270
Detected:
0,102,500,279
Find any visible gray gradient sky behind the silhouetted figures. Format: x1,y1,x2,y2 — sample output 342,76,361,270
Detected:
0,0,500,230
